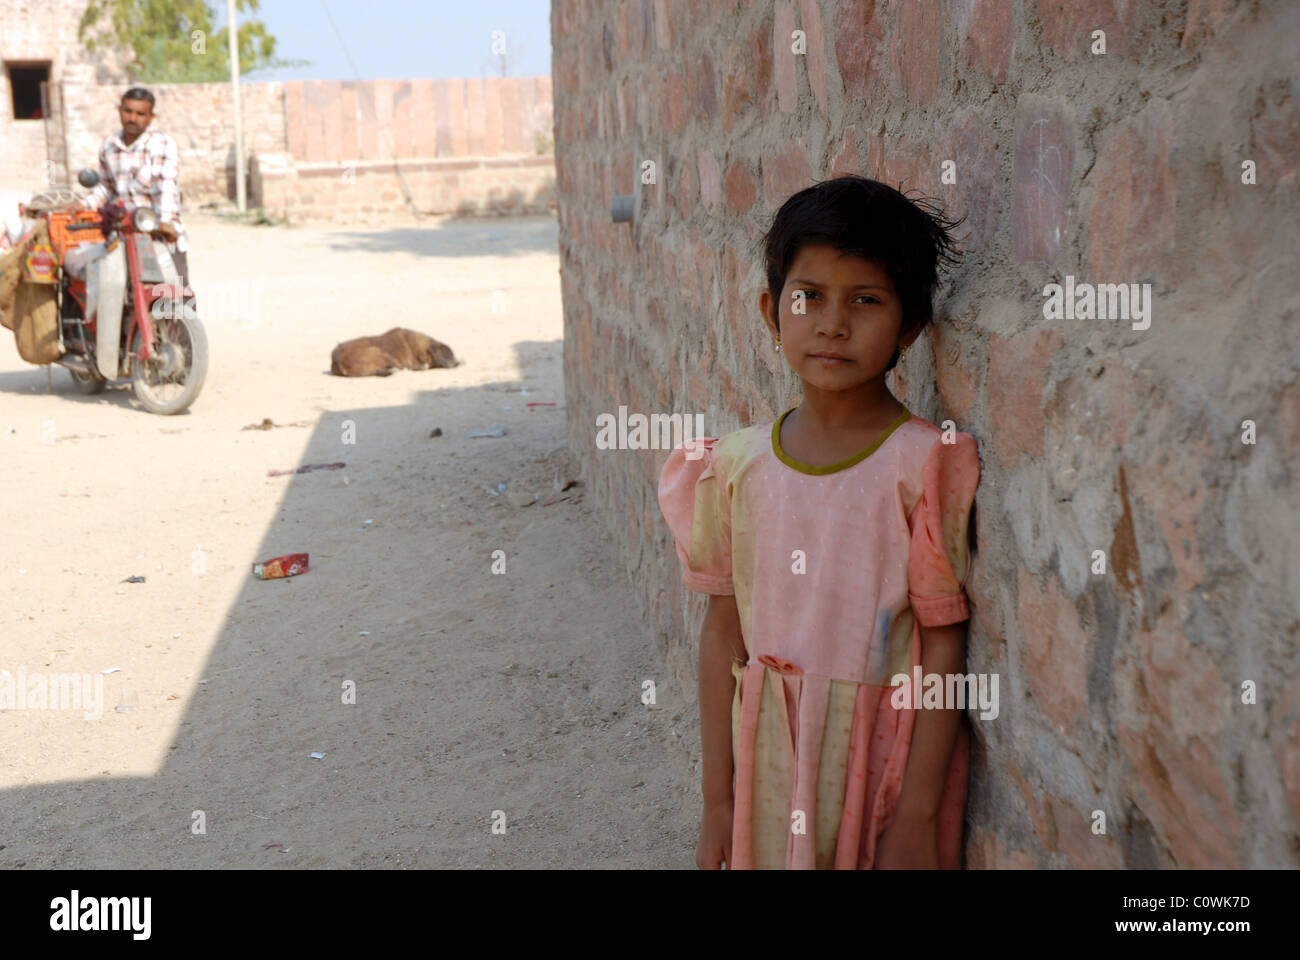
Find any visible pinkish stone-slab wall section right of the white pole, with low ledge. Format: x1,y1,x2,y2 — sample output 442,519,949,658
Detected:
251,77,555,221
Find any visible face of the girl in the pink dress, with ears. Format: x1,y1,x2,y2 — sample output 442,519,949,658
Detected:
761,245,915,392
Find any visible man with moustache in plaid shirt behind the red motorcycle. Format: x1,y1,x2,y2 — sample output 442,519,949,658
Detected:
82,87,190,291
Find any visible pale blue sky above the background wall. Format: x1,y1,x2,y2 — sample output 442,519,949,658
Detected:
226,0,551,81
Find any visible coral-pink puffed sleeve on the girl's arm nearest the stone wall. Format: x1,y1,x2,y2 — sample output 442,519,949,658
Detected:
907,433,979,627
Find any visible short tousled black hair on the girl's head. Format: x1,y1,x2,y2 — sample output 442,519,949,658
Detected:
763,176,962,367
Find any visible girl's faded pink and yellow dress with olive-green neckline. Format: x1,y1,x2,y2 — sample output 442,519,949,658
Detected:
659,410,979,869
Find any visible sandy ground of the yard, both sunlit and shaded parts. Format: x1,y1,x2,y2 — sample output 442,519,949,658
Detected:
0,209,698,869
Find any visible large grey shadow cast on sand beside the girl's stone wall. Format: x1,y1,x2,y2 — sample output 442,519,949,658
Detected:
0,343,696,869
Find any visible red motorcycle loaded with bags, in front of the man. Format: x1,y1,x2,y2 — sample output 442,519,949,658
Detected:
16,169,208,414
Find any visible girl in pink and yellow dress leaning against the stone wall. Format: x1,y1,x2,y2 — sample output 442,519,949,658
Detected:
659,177,979,869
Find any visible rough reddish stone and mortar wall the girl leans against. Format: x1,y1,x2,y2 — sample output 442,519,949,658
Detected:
551,0,1300,866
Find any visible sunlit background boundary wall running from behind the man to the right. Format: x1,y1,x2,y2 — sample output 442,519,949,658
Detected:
62,77,555,222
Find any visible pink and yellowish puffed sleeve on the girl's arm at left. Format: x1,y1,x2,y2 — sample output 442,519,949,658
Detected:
659,437,736,596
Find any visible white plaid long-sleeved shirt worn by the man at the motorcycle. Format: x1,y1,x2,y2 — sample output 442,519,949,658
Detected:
82,130,190,254
